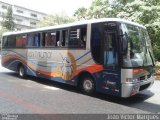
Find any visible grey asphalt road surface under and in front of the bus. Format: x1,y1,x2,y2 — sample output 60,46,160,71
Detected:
0,58,160,114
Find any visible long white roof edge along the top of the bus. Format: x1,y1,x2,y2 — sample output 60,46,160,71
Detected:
3,18,145,36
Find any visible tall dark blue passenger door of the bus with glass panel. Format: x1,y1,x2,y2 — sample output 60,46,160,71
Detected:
102,23,121,96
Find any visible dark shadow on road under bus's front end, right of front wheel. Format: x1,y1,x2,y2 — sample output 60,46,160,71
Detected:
96,90,160,113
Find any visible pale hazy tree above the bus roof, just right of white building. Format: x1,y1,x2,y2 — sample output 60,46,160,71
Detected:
37,14,74,27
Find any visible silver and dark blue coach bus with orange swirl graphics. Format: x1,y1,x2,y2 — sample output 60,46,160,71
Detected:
1,18,155,98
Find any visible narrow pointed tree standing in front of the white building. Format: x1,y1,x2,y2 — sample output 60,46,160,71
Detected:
2,6,15,31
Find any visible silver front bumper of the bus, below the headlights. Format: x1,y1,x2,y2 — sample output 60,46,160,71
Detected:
121,77,155,98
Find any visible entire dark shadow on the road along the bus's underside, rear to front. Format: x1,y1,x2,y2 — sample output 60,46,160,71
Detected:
3,72,160,113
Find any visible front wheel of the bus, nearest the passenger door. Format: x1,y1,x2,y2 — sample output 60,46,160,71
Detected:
80,77,95,95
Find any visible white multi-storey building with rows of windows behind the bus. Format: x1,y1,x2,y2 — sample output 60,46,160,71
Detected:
0,1,46,30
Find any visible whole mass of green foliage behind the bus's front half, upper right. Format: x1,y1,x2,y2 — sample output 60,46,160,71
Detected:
75,0,160,61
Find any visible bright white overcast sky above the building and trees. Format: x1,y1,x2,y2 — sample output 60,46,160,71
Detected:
0,0,92,16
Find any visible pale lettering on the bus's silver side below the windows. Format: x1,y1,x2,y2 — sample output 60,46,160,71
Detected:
28,51,52,59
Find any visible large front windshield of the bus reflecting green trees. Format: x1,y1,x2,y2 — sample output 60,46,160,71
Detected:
121,24,154,68
